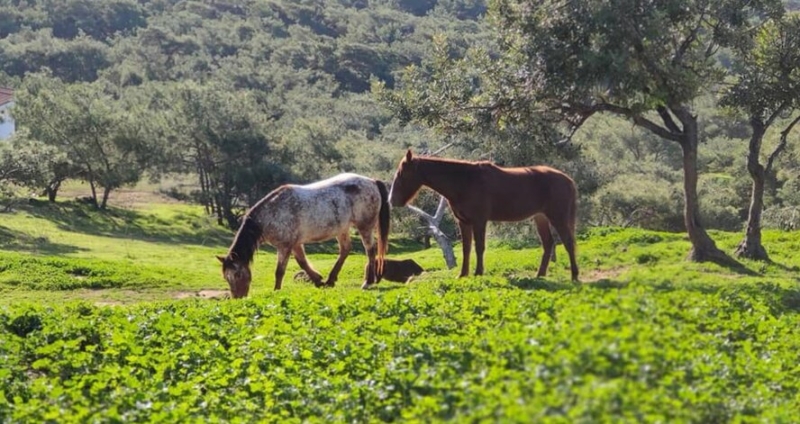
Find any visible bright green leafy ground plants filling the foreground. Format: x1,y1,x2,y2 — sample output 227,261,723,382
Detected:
0,280,800,422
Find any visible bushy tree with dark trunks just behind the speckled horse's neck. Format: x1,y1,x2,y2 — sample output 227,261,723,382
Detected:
162,82,288,229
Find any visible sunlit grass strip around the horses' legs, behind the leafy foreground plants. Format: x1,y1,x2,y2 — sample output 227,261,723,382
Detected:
0,195,800,304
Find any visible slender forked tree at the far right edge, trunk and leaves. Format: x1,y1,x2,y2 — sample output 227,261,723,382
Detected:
721,14,800,260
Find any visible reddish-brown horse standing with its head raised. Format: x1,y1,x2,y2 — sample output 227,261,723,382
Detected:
389,150,578,281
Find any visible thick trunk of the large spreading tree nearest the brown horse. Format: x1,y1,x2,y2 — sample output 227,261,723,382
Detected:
680,117,736,265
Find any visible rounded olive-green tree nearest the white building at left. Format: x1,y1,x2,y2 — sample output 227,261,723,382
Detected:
12,74,160,209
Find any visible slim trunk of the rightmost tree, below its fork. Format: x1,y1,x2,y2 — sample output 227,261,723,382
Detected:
736,119,769,261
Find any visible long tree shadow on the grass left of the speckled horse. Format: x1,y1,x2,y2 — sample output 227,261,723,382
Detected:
20,202,234,245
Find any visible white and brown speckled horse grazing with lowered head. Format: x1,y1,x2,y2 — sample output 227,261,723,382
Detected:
217,174,389,298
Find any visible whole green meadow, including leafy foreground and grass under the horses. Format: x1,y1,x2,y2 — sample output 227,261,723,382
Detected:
0,192,800,422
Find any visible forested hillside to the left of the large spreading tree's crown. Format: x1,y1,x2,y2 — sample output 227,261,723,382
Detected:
0,0,485,219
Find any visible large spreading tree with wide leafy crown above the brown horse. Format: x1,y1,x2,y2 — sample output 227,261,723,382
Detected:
376,0,783,264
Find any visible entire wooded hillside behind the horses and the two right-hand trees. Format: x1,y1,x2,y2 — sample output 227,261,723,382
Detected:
0,0,800,242
